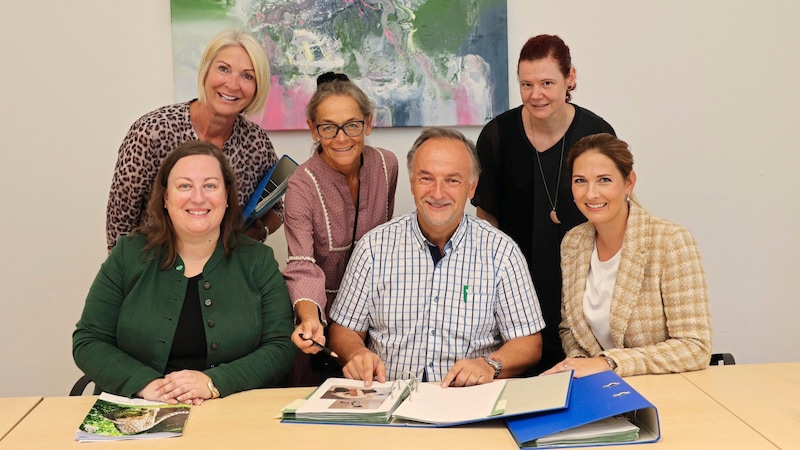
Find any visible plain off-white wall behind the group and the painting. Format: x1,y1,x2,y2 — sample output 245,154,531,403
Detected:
0,0,800,396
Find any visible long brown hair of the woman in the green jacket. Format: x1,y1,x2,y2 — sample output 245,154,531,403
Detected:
134,141,244,269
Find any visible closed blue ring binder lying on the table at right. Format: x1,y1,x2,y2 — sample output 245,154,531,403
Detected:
506,371,661,448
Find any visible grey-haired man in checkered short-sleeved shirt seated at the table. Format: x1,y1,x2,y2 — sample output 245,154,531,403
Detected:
329,128,545,387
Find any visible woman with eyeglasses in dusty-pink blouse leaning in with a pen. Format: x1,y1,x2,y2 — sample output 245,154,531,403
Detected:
283,72,397,386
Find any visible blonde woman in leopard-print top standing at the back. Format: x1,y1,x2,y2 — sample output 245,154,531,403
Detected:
106,31,283,251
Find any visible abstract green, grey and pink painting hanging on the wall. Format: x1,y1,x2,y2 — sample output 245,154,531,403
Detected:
171,0,508,130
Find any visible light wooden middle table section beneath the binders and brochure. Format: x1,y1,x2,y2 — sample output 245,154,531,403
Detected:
0,374,776,450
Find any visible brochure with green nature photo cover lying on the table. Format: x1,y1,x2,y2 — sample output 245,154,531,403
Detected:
75,392,191,442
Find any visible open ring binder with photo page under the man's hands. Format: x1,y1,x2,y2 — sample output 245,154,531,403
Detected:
281,371,572,427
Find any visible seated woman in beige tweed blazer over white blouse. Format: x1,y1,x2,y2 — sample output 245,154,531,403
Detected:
545,133,711,377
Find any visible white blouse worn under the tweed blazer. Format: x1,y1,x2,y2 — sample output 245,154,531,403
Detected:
583,243,622,350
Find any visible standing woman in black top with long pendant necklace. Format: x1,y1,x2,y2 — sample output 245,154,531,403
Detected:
472,35,614,374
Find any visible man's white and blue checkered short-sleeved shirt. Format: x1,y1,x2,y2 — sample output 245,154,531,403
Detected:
330,213,544,381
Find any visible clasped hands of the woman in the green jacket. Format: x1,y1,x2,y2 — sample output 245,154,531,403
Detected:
136,370,212,405
